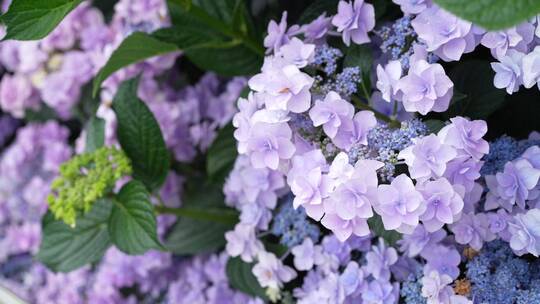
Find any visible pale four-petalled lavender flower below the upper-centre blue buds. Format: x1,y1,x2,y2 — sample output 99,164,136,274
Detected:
309,91,354,138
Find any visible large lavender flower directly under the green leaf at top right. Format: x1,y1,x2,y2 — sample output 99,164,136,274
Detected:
412,5,477,61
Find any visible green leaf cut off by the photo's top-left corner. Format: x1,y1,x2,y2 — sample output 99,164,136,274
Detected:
1,0,82,40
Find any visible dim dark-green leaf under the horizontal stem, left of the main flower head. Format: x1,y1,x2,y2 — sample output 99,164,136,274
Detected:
165,217,234,255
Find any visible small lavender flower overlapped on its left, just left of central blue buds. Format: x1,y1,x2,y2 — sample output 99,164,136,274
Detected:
332,111,377,150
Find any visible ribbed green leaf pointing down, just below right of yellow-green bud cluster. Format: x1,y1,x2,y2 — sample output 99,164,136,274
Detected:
109,180,163,255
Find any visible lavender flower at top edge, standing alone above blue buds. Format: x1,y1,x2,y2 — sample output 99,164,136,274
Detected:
332,0,375,46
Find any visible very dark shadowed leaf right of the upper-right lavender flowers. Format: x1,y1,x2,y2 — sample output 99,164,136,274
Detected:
445,60,506,119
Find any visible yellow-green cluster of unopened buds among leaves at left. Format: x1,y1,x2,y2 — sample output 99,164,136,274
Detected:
47,147,132,227
